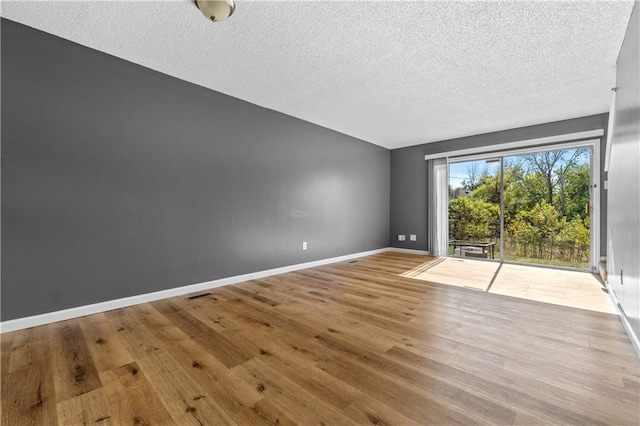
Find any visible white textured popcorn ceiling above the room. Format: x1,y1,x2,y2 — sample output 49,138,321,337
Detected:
1,0,633,148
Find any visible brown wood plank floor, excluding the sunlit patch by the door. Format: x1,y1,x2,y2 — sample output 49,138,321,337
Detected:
1,252,640,425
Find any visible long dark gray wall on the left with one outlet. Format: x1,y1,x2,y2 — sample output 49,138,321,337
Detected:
1,19,390,321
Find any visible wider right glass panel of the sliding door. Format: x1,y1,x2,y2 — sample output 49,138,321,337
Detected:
503,147,591,269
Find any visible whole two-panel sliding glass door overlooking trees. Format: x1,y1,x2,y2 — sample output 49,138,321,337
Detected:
448,146,597,269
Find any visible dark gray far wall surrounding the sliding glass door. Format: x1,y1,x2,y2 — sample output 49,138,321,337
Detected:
389,114,609,256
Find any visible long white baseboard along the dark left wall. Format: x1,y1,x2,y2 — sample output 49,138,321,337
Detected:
0,248,395,334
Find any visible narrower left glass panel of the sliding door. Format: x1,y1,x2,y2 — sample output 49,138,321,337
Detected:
449,158,502,260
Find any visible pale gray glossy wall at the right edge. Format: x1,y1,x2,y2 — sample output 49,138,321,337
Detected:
607,2,640,344
